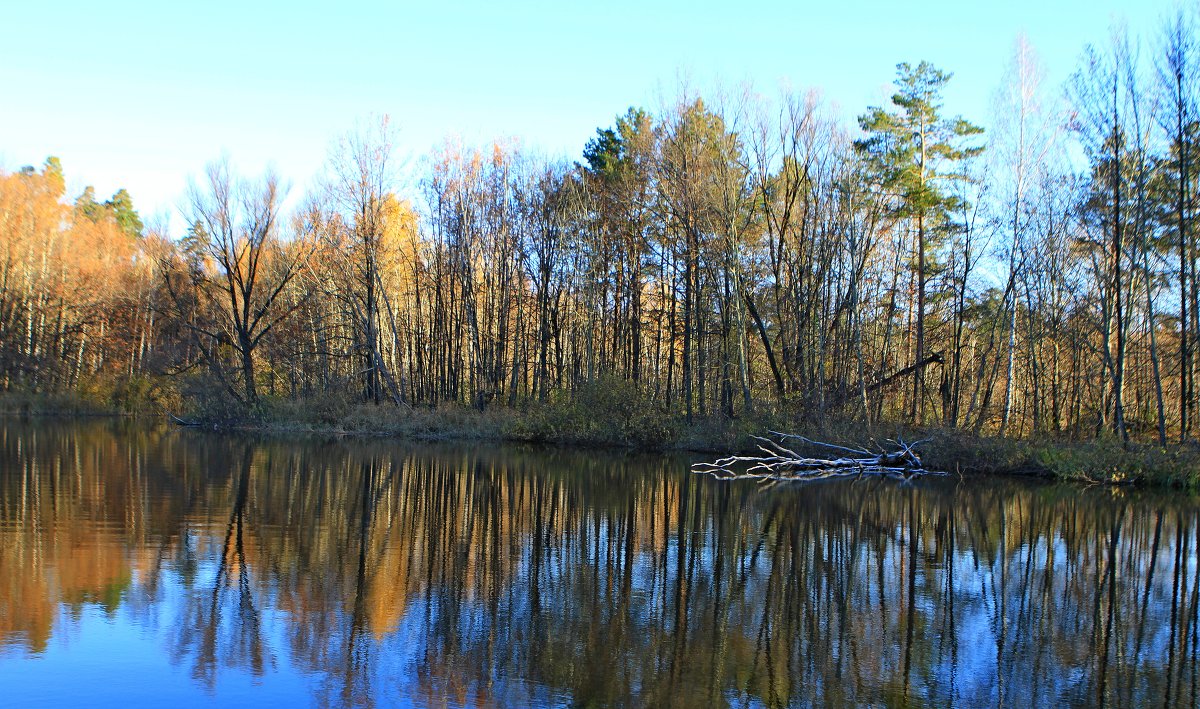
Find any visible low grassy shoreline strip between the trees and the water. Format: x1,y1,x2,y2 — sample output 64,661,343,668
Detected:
0,399,1200,492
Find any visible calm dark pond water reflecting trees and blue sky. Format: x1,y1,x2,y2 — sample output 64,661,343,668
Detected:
0,421,1200,707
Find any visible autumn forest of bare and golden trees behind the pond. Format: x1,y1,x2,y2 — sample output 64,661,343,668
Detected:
0,20,1200,455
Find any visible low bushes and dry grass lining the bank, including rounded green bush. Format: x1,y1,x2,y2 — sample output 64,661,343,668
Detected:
0,378,1200,492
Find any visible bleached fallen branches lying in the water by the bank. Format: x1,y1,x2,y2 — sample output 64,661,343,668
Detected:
691,431,944,482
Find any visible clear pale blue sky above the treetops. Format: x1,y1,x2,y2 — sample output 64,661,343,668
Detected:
0,0,1180,227
